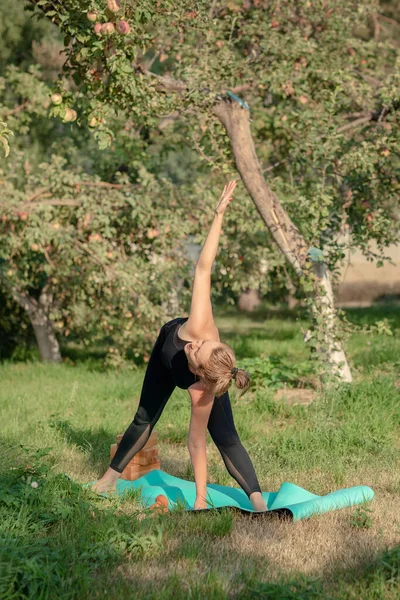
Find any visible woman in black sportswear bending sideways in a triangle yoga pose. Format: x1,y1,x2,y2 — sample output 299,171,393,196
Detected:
93,181,266,511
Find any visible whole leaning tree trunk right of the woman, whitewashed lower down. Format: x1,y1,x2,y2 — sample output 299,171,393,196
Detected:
214,100,352,382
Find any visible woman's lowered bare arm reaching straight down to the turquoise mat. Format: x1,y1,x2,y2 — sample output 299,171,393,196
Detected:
187,382,214,509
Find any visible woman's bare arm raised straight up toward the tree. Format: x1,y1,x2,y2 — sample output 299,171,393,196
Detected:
182,181,236,340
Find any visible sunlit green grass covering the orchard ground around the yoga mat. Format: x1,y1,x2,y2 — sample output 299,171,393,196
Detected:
0,306,400,600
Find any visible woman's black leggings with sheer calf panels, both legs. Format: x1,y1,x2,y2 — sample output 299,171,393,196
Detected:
110,328,261,496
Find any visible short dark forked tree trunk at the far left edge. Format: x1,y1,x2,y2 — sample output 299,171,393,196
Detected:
12,289,61,363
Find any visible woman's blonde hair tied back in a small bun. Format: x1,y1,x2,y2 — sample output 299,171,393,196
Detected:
197,342,250,398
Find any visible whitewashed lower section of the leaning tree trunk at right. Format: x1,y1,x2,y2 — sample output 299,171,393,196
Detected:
312,262,353,383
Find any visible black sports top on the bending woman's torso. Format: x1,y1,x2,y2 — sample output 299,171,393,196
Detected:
161,317,199,390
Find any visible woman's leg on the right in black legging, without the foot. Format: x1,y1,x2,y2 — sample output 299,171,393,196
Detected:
208,392,261,497
